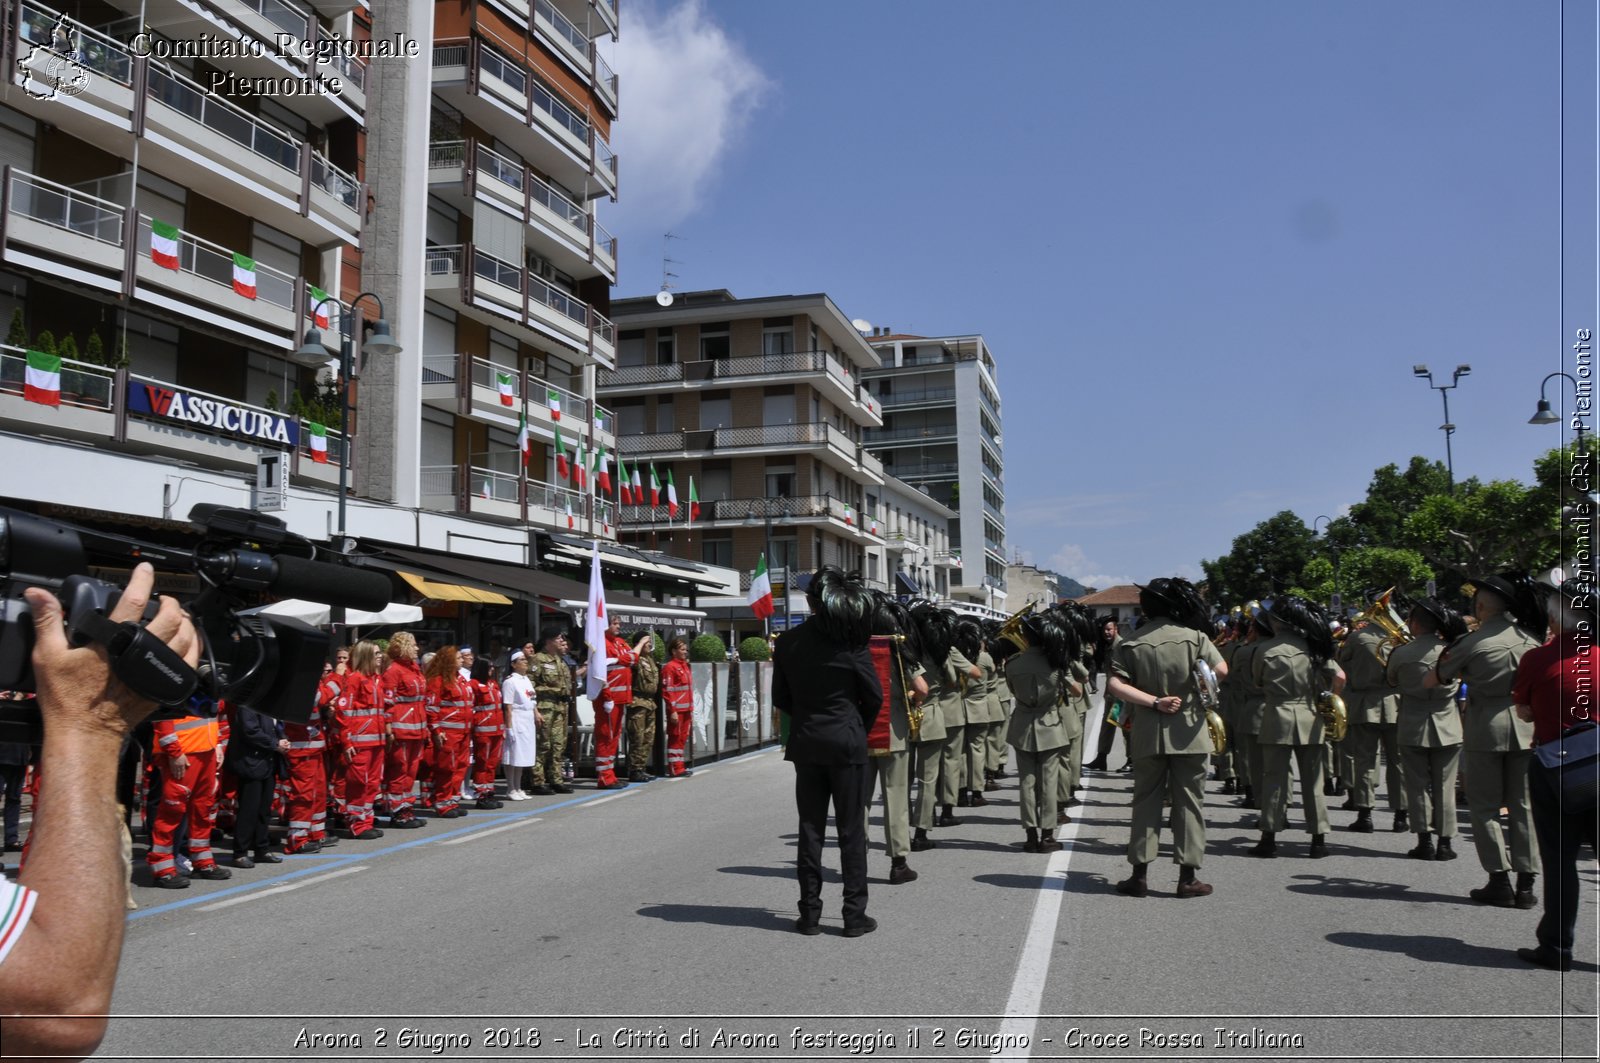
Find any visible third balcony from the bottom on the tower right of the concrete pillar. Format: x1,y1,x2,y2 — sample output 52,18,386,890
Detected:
426,243,616,368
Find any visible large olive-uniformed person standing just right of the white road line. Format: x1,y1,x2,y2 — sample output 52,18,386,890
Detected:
1106,578,1227,897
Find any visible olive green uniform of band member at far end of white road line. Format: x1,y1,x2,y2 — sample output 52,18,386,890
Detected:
1005,647,1083,831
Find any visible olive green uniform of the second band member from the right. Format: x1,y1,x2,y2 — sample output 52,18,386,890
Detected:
1386,634,1461,839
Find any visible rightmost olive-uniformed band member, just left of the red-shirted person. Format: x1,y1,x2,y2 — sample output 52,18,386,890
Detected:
1427,572,1547,908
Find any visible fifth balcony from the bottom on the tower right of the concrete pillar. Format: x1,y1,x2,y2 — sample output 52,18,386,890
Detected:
432,37,616,199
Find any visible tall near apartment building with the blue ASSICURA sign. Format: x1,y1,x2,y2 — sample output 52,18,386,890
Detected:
0,0,630,582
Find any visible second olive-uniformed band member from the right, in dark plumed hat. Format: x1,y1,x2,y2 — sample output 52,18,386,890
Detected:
1386,597,1467,860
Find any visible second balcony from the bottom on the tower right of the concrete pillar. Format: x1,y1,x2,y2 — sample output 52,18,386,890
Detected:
422,354,604,450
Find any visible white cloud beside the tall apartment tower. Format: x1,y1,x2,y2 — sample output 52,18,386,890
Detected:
608,0,771,232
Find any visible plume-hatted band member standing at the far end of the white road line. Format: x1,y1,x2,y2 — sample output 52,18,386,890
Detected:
1005,610,1083,853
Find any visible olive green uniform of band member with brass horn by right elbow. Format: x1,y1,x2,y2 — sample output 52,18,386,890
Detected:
1251,634,1339,834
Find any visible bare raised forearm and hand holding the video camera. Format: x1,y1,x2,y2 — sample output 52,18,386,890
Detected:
0,564,200,1058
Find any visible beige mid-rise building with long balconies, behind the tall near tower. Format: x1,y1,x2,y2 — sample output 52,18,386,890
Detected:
598,291,888,601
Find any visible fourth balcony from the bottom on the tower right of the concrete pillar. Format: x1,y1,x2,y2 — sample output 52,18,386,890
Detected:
427,141,616,283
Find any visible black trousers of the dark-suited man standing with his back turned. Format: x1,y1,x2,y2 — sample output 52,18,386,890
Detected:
795,762,870,927
